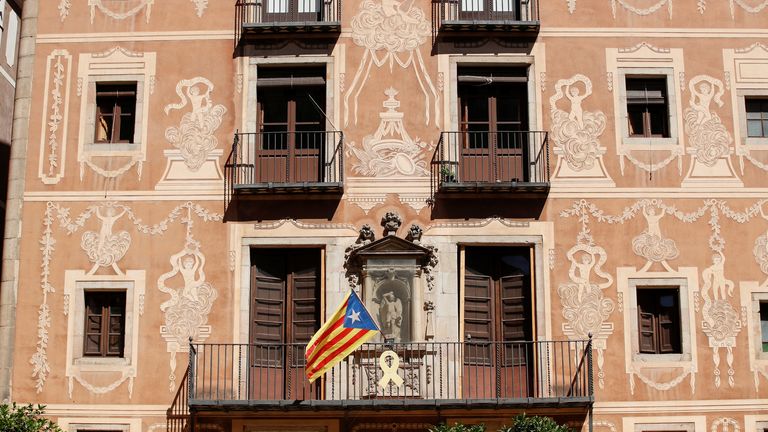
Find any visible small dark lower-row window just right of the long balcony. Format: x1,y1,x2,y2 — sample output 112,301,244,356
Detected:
637,287,682,354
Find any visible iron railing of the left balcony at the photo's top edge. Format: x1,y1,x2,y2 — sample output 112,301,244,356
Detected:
235,0,341,43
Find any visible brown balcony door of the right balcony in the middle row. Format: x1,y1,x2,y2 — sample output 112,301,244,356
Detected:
458,69,529,183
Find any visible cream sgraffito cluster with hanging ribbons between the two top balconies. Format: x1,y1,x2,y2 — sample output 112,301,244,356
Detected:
344,0,440,127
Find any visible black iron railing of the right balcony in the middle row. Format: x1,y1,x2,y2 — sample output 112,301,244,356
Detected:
431,131,549,195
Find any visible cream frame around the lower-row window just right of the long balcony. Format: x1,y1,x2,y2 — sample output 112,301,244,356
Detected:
616,267,699,373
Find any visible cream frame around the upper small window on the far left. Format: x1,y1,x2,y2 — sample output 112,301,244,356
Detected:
77,47,157,169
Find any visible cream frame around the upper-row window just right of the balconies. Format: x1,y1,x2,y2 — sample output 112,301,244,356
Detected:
605,42,685,175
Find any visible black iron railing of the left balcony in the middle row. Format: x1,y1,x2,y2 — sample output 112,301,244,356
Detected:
224,131,344,204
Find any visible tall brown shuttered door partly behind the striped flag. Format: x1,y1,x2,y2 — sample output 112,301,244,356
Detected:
248,249,321,400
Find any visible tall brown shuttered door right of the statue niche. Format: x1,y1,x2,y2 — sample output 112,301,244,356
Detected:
462,247,535,399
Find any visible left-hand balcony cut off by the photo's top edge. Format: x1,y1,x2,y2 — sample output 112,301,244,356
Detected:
235,0,341,43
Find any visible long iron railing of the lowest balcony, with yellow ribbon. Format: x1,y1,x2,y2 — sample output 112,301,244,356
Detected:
188,340,593,409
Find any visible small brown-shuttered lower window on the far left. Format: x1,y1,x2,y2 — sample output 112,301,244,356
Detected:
83,291,125,357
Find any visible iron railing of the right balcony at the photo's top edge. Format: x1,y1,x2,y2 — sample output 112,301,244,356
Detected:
432,0,539,28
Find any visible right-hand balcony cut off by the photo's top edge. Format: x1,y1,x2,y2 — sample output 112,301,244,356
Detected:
432,0,540,39
